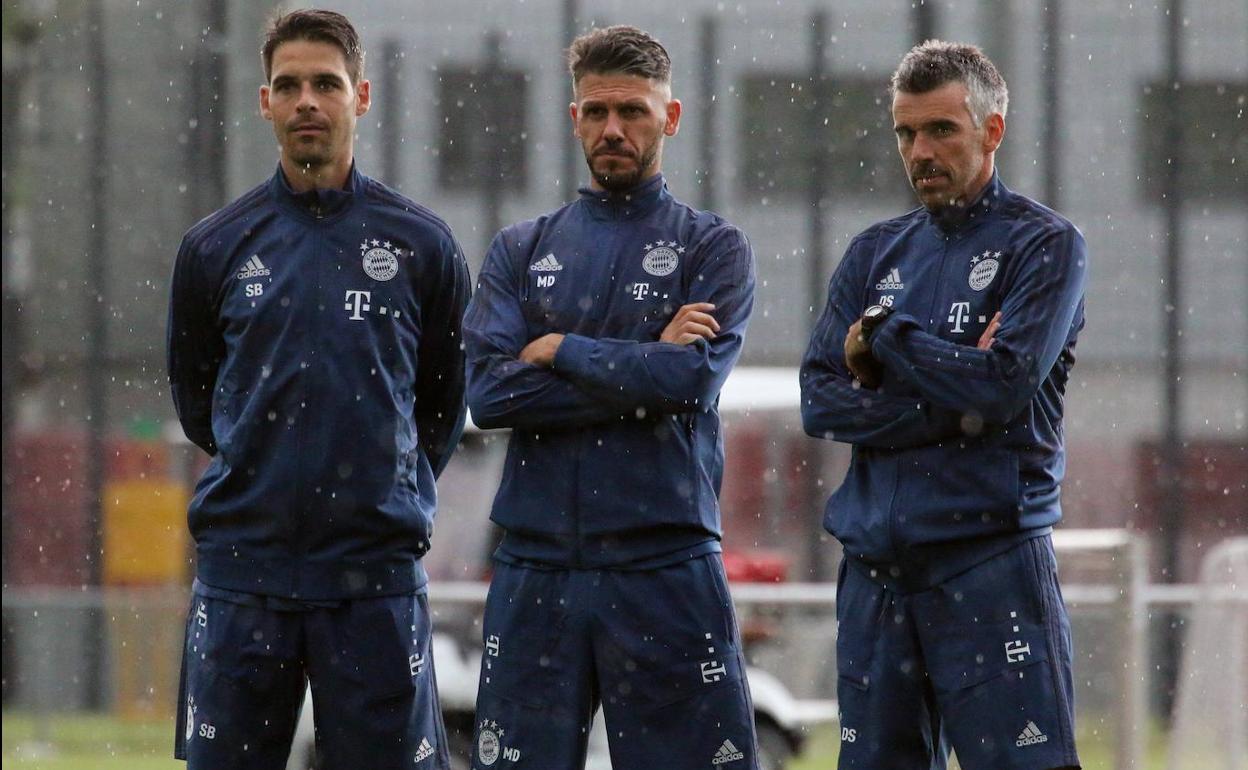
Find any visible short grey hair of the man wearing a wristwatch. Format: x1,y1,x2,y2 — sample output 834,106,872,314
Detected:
890,40,1010,126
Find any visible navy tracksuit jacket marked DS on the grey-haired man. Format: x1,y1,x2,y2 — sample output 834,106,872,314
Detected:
801,175,1087,588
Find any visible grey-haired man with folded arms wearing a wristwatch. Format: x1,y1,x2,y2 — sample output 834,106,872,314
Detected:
801,41,1087,770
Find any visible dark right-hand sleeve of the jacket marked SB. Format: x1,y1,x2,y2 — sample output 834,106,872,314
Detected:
414,235,472,478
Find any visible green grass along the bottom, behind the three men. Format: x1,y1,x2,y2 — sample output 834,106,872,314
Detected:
2,711,1166,770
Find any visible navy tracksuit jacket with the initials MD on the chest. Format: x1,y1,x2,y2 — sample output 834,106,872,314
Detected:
464,176,754,568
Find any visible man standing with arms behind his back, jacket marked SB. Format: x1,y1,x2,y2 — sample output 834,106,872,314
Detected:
168,10,469,770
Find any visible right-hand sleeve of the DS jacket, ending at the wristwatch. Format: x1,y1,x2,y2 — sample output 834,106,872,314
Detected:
871,226,1087,424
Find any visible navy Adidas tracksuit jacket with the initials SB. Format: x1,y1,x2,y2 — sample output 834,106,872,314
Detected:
167,168,470,600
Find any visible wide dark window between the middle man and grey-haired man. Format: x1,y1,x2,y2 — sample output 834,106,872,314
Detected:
740,72,909,200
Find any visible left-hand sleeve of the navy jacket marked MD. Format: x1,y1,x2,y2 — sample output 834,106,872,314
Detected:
464,231,624,429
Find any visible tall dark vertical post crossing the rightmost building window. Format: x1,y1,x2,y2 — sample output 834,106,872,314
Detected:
1157,0,1184,719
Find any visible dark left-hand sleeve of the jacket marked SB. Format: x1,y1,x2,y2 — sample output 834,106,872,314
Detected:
165,230,226,456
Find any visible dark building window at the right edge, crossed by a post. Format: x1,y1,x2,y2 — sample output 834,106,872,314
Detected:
1139,81,1248,206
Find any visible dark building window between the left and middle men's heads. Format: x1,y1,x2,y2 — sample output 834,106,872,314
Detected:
438,67,529,191
